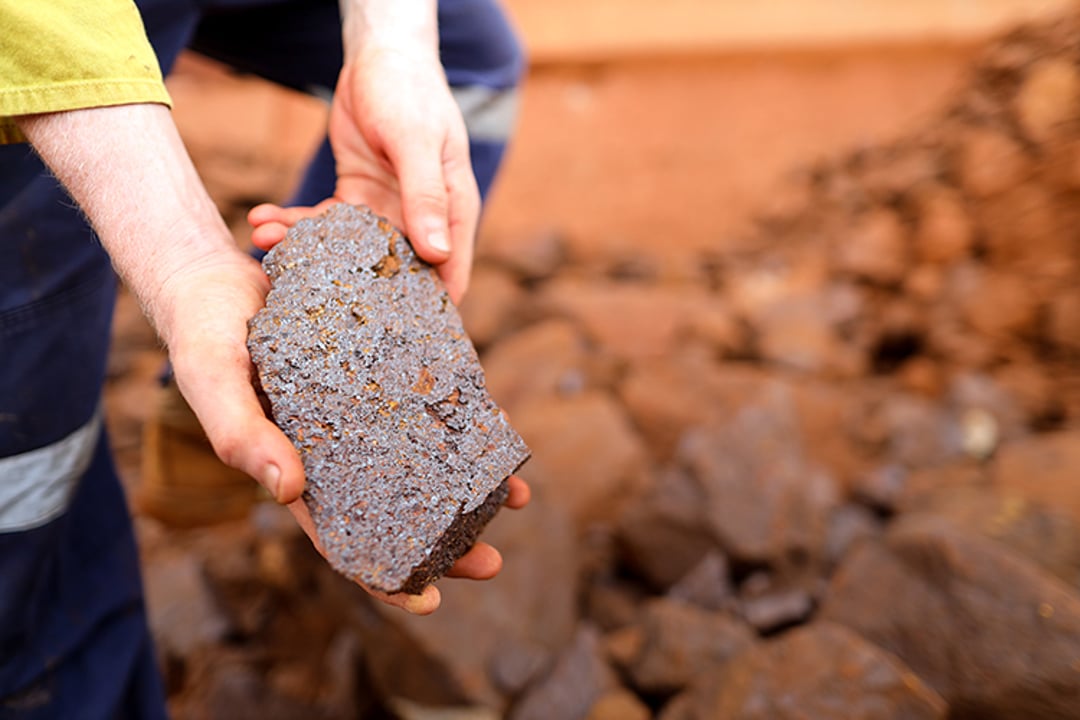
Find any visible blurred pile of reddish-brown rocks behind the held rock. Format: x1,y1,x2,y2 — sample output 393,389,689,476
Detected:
111,11,1080,720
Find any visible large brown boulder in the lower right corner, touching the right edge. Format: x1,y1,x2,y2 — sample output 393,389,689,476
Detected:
822,514,1080,720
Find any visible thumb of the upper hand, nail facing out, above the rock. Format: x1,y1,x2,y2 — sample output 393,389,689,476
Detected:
391,142,453,264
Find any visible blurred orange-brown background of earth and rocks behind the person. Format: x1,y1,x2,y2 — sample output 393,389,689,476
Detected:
107,0,1080,720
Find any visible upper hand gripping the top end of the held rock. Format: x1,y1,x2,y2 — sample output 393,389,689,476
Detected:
248,45,480,302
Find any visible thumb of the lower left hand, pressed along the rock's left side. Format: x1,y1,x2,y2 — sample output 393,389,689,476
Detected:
174,343,303,503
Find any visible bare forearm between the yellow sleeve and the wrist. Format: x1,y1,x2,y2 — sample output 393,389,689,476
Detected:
18,104,235,342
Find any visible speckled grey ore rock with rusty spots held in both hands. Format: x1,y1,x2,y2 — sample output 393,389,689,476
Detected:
247,204,529,593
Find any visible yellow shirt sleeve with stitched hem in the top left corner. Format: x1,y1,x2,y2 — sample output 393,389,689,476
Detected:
0,0,171,142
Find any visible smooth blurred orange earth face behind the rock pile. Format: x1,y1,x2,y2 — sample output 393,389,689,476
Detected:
484,42,972,262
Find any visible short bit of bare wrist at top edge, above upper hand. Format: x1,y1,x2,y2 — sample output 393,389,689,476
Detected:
340,0,438,63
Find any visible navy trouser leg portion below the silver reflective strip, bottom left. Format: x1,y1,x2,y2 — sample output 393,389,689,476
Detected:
0,433,165,720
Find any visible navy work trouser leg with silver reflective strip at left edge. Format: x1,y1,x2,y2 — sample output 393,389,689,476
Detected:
0,0,208,720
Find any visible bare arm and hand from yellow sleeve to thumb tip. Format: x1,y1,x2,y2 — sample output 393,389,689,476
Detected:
19,104,303,502
